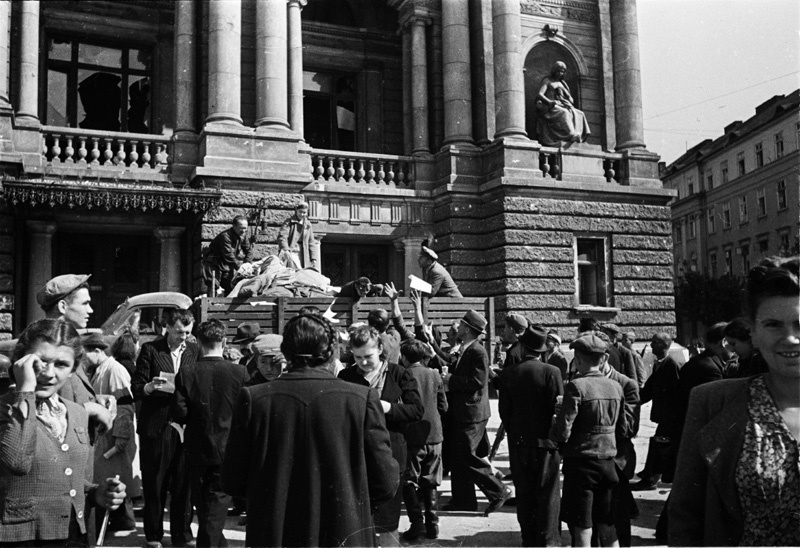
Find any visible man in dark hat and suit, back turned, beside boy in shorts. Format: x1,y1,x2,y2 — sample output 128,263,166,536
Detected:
499,326,564,546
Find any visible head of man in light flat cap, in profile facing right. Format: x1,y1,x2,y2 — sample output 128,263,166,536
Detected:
36,274,93,329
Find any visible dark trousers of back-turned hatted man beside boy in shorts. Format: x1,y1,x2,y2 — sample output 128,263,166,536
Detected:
508,444,561,546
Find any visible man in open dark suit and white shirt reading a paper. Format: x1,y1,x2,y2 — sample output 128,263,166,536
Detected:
131,310,199,548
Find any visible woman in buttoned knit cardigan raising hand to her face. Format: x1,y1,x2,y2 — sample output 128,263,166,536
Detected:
0,319,125,546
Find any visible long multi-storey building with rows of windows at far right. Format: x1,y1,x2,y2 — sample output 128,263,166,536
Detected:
662,90,800,332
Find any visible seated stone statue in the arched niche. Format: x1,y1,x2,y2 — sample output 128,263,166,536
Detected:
536,61,590,146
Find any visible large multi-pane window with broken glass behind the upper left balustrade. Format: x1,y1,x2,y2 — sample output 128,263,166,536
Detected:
44,36,152,133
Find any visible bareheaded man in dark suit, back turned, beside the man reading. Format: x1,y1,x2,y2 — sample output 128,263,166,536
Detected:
170,320,248,546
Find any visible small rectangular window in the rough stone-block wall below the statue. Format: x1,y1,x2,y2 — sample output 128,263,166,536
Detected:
574,236,612,307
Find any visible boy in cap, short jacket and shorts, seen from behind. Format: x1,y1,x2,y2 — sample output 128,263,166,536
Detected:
550,333,623,546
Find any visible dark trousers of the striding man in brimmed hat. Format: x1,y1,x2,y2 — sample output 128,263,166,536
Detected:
449,420,506,506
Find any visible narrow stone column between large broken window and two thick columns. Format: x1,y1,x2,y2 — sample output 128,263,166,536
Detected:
174,0,197,134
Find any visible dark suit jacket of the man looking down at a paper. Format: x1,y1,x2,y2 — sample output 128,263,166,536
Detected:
131,337,199,438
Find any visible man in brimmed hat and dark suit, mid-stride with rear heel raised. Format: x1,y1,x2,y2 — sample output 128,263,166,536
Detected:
443,310,511,516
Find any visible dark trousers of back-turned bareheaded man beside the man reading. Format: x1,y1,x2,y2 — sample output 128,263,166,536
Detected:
191,465,231,547
